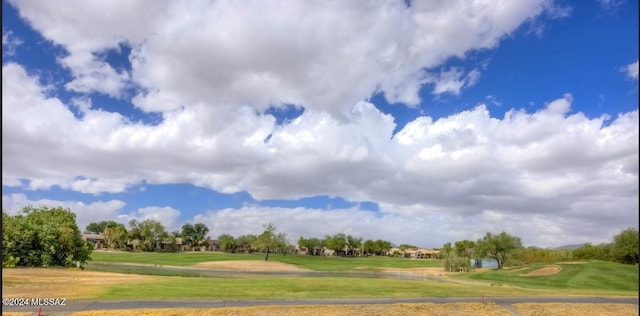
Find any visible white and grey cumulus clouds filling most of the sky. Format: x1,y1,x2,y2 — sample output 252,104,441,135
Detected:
2,0,638,246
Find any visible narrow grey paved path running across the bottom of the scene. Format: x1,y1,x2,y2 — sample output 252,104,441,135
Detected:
2,297,638,315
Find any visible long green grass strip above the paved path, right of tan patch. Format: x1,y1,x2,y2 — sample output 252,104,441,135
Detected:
96,277,557,300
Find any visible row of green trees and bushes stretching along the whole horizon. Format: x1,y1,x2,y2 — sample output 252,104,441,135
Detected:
2,206,640,271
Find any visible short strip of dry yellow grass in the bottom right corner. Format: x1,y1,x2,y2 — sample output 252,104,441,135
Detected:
512,303,638,316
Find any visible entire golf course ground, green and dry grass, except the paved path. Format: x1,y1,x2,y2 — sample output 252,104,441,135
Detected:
2,252,638,316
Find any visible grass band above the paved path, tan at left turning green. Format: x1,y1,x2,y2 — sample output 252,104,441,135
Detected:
2,268,555,300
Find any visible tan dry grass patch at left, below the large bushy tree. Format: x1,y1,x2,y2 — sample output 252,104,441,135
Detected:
2,268,155,299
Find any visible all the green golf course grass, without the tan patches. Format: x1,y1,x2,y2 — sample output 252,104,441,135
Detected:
88,252,638,299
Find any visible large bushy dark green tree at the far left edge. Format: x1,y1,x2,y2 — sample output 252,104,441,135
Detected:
2,206,93,267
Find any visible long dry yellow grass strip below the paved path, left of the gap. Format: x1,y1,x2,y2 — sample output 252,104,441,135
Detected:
72,303,511,316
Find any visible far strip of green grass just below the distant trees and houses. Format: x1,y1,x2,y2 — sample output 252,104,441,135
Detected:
91,251,442,271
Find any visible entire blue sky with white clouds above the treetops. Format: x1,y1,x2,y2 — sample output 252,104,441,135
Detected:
2,0,639,247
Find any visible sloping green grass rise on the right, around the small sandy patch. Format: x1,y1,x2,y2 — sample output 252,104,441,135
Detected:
450,261,638,296
